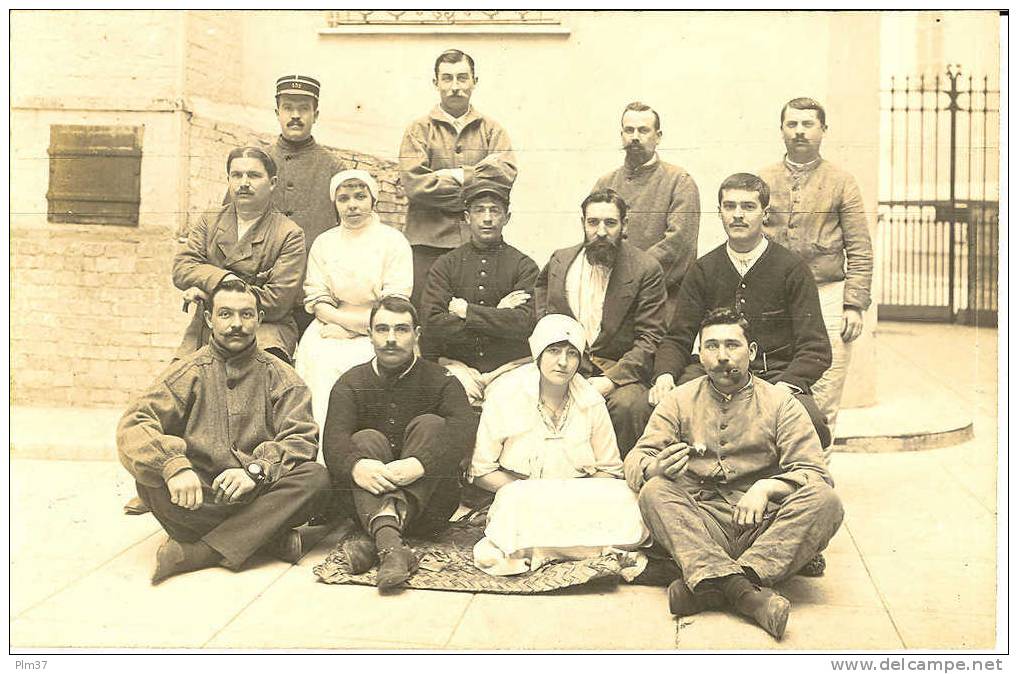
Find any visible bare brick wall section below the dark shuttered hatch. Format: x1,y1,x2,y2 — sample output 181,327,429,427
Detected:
10,227,185,406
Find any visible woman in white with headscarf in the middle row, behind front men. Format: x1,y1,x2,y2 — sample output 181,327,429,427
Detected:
294,170,413,429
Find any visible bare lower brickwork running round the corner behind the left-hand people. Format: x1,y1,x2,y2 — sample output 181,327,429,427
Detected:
10,111,406,407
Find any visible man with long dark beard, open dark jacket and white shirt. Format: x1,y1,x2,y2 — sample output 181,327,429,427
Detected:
534,189,666,456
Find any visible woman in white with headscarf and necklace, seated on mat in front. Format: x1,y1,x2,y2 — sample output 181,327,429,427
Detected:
468,315,649,576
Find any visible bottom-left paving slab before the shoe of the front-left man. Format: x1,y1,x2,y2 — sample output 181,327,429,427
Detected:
11,536,292,649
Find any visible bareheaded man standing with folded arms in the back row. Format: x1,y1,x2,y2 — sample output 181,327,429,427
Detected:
399,49,516,312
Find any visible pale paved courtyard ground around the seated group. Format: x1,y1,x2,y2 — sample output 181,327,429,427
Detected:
10,324,993,651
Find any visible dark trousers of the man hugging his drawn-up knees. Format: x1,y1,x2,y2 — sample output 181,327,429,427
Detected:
333,414,460,537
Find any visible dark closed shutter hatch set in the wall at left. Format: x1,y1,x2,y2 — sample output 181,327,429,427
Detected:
46,124,144,225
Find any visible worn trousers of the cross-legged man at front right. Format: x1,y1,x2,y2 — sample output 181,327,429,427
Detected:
639,476,845,589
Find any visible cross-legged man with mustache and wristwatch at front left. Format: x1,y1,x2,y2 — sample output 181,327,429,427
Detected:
117,279,329,583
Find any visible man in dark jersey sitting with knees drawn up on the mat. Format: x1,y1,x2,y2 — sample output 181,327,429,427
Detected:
322,295,476,591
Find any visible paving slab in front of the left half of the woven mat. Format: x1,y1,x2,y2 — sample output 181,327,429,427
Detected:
207,567,472,649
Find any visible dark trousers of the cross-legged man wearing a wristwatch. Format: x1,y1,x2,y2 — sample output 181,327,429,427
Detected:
137,461,329,569
